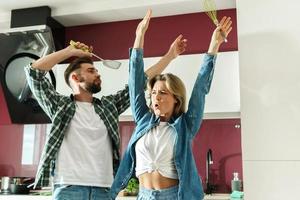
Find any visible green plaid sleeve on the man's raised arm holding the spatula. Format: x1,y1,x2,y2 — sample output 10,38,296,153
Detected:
24,65,60,119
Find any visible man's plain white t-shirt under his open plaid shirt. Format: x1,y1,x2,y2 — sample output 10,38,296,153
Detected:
53,101,113,187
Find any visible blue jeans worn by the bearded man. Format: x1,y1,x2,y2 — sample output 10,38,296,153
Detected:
52,184,110,200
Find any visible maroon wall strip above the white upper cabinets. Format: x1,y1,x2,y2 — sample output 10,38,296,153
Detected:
66,9,237,59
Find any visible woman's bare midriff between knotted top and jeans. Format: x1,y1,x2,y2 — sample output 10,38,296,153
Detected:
139,171,179,190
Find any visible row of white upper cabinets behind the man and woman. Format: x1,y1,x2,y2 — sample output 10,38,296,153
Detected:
56,51,240,120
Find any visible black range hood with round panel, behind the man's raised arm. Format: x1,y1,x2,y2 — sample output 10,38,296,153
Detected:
0,6,65,124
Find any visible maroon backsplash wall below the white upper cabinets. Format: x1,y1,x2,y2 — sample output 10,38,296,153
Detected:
0,119,242,192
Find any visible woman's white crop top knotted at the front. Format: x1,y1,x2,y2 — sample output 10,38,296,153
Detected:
135,122,178,179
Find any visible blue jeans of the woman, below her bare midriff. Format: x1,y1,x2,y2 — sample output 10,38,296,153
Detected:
137,186,178,200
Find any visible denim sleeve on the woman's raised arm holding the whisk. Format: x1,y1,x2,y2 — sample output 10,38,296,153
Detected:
186,54,217,138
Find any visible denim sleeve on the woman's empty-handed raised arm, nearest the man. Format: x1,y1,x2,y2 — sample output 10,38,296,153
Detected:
128,49,148,123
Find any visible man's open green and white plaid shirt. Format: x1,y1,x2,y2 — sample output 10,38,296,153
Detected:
25,65,130,187
